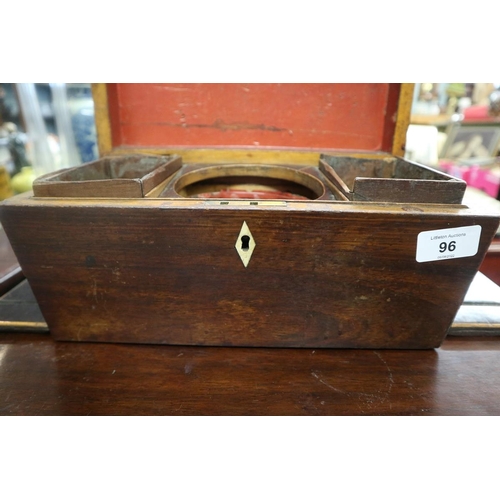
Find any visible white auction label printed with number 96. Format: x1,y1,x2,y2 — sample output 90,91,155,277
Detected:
417,226,481,262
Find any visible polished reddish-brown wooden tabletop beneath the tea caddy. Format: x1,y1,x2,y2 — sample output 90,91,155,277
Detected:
0,333,500,415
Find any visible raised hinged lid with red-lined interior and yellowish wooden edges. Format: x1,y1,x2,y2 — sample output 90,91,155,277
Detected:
93,83,413,164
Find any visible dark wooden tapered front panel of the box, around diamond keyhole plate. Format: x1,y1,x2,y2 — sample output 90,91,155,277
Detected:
1,191,498,348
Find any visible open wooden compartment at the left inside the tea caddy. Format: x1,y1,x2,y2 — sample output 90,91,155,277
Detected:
33,155,182,198
